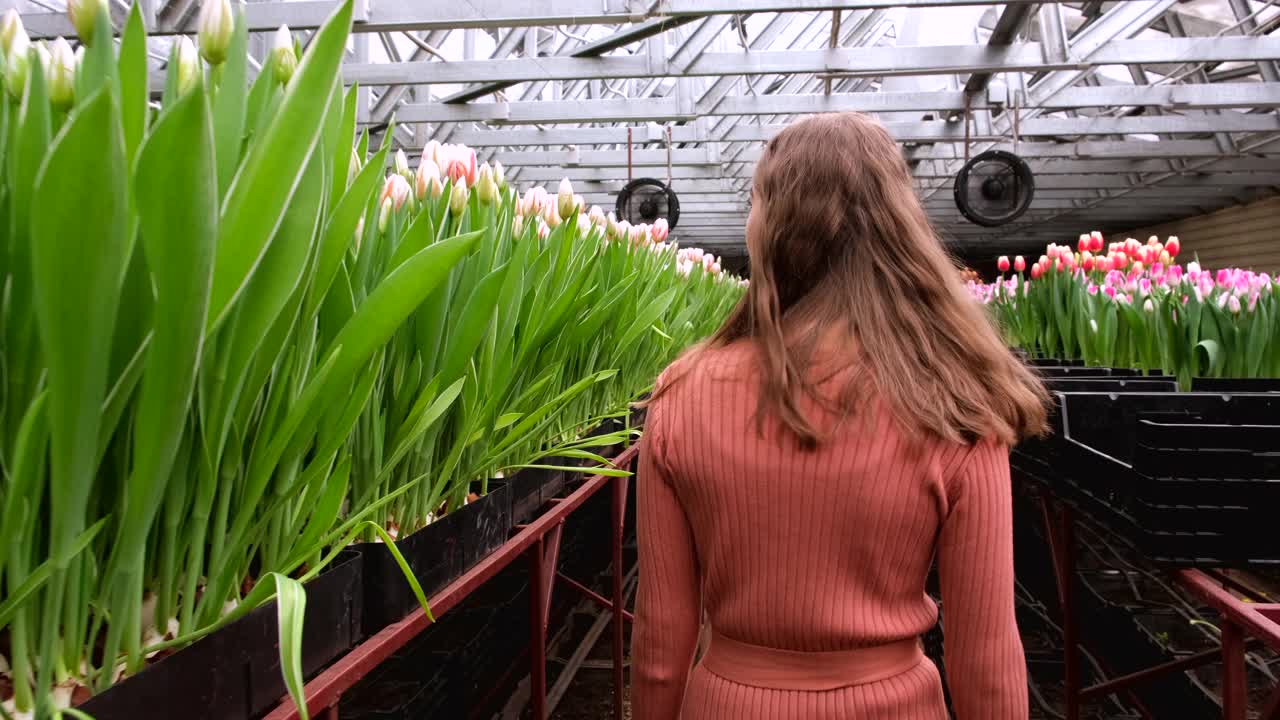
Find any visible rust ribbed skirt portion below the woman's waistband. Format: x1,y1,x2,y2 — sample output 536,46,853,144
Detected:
680,659,947,720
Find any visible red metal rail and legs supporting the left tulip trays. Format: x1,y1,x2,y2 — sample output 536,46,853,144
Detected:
264,446,639,720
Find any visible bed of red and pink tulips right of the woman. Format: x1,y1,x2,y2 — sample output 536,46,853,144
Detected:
968,232,1280,388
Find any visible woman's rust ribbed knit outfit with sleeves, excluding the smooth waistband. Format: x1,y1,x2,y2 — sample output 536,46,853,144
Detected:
631,343,1028,720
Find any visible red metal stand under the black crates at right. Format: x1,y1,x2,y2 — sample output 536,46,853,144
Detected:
1041,496,1280,720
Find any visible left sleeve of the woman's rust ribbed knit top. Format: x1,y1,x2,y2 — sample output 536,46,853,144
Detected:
631,399,701,720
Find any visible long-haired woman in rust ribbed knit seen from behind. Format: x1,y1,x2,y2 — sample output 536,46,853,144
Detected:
631,114,1047,720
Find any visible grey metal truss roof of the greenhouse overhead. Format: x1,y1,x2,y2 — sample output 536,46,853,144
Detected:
17,0,1280,254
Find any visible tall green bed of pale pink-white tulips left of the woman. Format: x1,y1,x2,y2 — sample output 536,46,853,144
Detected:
0,1,741,717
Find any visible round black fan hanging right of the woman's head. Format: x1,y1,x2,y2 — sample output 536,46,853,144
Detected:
955,150,1036,228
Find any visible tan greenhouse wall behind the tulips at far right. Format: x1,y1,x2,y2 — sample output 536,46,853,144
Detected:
1128,197,1280,273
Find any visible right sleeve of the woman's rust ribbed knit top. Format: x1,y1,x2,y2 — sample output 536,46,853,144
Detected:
938,442,1028,720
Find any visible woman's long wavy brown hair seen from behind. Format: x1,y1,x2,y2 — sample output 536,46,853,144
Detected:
665,113,1048,447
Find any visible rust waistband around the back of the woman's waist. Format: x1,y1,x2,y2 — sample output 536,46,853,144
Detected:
701,630,924,691
